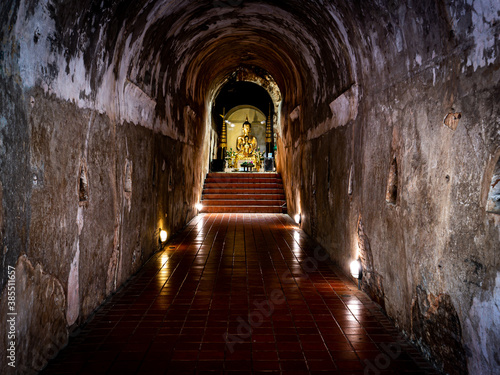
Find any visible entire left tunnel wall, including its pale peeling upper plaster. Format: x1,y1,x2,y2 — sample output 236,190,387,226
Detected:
0,1,208,374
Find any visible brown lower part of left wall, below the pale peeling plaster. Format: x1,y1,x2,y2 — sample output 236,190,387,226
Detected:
0,81,202,373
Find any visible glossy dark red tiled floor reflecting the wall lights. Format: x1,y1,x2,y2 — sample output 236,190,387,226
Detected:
43,214,440,375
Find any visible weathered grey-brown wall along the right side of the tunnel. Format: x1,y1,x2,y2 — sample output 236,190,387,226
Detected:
279,1,500,374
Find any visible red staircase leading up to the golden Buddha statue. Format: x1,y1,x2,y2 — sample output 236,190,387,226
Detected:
200,172,286,213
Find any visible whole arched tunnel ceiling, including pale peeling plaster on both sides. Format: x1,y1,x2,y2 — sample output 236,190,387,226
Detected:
4,0,462,139
